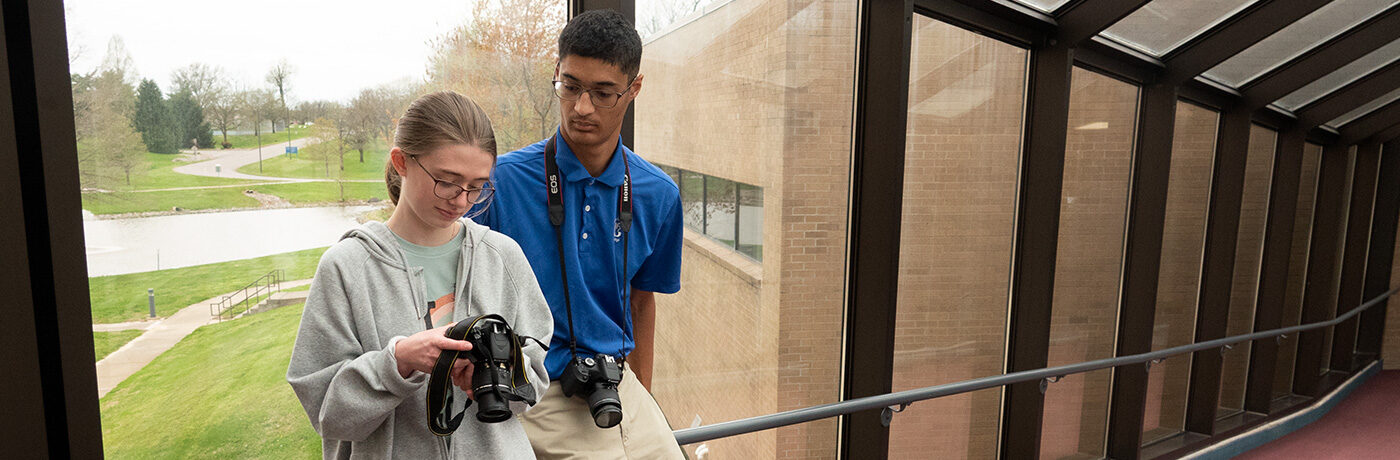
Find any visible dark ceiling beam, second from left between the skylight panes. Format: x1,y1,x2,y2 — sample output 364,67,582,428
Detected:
1163,0,1331,82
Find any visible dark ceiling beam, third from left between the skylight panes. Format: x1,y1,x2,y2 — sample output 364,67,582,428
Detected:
1242,3,1400,106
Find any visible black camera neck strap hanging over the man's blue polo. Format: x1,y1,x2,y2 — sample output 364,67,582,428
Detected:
545,134,633,357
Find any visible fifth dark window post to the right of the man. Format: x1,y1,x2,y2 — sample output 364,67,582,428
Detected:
1245,129,1304,414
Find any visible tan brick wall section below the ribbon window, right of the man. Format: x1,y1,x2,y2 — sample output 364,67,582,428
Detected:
649,229,778,459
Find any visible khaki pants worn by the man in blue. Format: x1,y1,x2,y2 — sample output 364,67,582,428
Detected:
524,372,685,460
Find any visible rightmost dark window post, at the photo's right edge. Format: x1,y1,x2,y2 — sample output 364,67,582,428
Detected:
1357,140,1400,357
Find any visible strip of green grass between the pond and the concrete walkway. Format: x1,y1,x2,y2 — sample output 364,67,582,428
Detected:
88,247,326,324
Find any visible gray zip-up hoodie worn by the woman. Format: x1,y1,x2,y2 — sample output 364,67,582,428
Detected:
287,220,553,459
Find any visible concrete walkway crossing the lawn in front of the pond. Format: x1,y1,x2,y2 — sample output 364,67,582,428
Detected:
92,280,311,397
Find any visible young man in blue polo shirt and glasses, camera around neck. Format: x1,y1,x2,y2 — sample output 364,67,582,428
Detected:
477,11,683,459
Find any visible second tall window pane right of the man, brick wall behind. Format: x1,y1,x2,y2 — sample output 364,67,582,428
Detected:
889,15,1028,459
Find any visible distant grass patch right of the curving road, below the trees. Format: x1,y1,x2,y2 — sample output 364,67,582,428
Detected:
238,141,389,180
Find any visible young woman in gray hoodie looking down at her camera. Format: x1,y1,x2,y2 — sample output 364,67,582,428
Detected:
287,92,553,459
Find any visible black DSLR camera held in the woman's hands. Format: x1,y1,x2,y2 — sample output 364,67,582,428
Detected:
427,315,547,436
